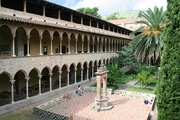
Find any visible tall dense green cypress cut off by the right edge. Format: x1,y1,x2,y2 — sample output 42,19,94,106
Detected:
157,0,180,120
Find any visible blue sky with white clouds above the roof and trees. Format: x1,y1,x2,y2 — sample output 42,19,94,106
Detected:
47,0,167,17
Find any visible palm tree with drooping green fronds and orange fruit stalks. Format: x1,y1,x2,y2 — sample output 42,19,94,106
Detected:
131,6,166,77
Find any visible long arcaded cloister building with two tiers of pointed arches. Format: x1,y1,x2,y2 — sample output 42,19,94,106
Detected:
0,0,131,110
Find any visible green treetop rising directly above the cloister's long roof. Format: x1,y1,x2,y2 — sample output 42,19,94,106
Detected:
77,7,101,18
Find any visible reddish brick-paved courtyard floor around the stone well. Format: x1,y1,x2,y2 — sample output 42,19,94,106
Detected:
38,92,152,120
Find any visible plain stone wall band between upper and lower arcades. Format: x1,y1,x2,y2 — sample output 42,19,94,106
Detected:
0,53,117,75
